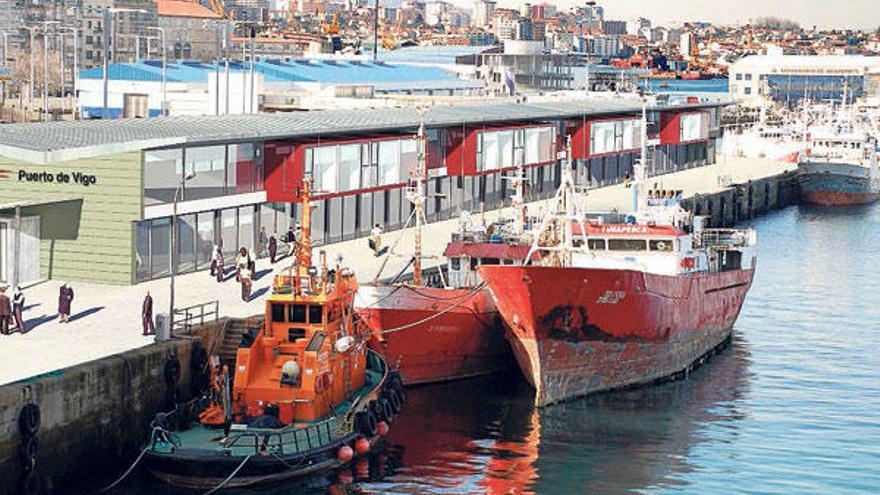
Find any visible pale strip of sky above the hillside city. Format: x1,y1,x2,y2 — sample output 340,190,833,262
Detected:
488,0,880,29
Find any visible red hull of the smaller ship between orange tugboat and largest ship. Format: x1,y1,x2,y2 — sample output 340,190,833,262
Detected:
355,285,511,385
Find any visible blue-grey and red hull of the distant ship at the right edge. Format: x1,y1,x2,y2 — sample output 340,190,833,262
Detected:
798,162,880,206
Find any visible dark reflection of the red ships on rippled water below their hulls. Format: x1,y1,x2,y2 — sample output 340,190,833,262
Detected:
360,337,750,494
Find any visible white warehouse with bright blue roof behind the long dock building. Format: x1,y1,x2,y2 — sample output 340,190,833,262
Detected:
79,59,483,118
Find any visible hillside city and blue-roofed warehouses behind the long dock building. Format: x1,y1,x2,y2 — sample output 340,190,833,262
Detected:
0,0,880,122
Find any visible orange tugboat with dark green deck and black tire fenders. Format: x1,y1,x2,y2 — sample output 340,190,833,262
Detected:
144,184,403,489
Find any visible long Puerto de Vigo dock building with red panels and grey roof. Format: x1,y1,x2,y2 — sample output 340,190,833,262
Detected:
0,99,722,285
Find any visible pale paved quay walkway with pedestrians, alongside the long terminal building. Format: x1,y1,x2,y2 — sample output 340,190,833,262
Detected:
0,157,794,384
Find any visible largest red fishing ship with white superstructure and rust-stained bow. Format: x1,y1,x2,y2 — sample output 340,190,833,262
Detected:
479,133,756,406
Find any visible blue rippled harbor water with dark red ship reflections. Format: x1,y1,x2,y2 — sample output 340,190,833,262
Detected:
99,205,880,494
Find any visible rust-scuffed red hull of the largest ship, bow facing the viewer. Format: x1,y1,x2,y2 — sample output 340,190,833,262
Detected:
479,266,754,406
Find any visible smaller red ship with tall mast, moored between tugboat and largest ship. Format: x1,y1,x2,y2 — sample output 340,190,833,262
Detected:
355,123,529,385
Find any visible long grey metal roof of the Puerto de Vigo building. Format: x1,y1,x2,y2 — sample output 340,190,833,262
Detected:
0,100,719,163
